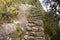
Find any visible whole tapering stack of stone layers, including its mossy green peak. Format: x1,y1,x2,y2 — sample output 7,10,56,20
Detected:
21,6,45,40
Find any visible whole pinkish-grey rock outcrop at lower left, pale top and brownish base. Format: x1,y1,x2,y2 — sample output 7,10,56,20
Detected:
0,23,20,40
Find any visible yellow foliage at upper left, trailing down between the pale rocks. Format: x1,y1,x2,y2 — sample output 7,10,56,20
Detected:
0,0,23,36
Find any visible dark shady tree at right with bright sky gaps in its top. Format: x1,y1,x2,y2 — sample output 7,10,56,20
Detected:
44,0,60,40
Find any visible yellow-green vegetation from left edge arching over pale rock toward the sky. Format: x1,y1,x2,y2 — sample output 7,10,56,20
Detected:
0,0,42,35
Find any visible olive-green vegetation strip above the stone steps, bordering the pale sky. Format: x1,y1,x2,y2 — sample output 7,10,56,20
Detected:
20,0,45,16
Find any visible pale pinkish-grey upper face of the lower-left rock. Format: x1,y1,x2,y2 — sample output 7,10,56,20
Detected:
0,23,17,37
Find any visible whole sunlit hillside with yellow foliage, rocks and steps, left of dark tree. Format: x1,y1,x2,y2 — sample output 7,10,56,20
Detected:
0,0,45,40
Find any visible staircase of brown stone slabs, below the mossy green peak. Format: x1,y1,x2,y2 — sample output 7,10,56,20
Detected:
21,16,44,40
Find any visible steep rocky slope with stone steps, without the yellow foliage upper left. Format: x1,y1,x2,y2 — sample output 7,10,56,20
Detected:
0,0,45,40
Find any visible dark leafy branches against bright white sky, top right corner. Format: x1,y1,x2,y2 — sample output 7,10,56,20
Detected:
45,0,60,23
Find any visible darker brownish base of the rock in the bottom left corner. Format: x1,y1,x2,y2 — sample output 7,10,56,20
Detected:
0,31,20,40
